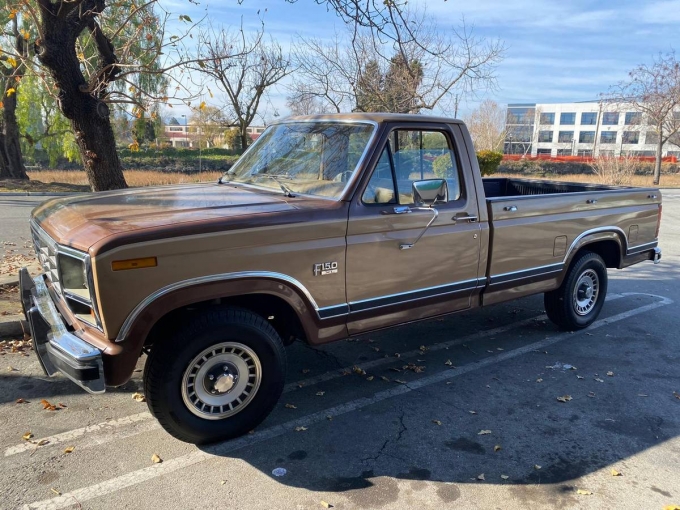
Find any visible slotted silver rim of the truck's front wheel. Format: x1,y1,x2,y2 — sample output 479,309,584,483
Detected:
182,342,262,420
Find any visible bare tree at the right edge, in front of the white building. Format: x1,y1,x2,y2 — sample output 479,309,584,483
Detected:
605,52,680,185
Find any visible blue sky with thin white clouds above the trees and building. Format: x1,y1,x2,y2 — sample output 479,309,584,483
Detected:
160,0,680,119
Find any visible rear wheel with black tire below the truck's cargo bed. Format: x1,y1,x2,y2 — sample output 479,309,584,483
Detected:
543,252,607,331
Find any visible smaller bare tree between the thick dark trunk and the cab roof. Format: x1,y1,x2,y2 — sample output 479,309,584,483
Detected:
194,23,292,148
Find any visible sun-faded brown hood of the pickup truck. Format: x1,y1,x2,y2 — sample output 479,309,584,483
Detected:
32,184,298,251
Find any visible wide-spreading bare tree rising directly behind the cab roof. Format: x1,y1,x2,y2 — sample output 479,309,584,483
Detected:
293,6,504,112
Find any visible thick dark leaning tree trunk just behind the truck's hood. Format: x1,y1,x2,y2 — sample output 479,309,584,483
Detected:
37,2,127,191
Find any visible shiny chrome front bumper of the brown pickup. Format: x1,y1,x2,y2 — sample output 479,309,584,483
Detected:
19,268,106,393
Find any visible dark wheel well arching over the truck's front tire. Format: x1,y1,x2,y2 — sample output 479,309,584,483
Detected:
144,294,307,348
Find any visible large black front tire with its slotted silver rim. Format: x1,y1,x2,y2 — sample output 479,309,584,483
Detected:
144,308,286,444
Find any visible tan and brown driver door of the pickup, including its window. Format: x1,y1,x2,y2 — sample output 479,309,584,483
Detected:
347,127,481,334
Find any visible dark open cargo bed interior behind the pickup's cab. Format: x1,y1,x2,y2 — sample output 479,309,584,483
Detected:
482,177,625,198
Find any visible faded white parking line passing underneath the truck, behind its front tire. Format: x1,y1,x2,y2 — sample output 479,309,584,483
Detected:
5,294,624,457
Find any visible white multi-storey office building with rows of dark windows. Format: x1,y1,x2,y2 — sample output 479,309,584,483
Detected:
504,101,680,157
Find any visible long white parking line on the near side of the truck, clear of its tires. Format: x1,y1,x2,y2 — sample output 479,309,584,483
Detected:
23,293,673,510
